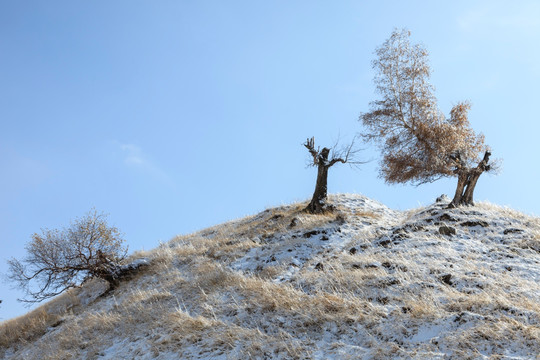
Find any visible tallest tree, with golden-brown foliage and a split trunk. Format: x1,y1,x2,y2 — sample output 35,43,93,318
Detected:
360,30,491,206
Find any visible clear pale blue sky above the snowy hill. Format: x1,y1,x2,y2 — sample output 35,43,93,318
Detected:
0,0,540,320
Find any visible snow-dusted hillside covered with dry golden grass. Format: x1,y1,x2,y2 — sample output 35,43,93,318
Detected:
0,195,540,359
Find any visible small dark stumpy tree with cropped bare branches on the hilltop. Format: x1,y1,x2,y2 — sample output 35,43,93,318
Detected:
304,137,362,214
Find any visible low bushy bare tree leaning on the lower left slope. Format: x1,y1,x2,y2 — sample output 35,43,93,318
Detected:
8,210,127,302
